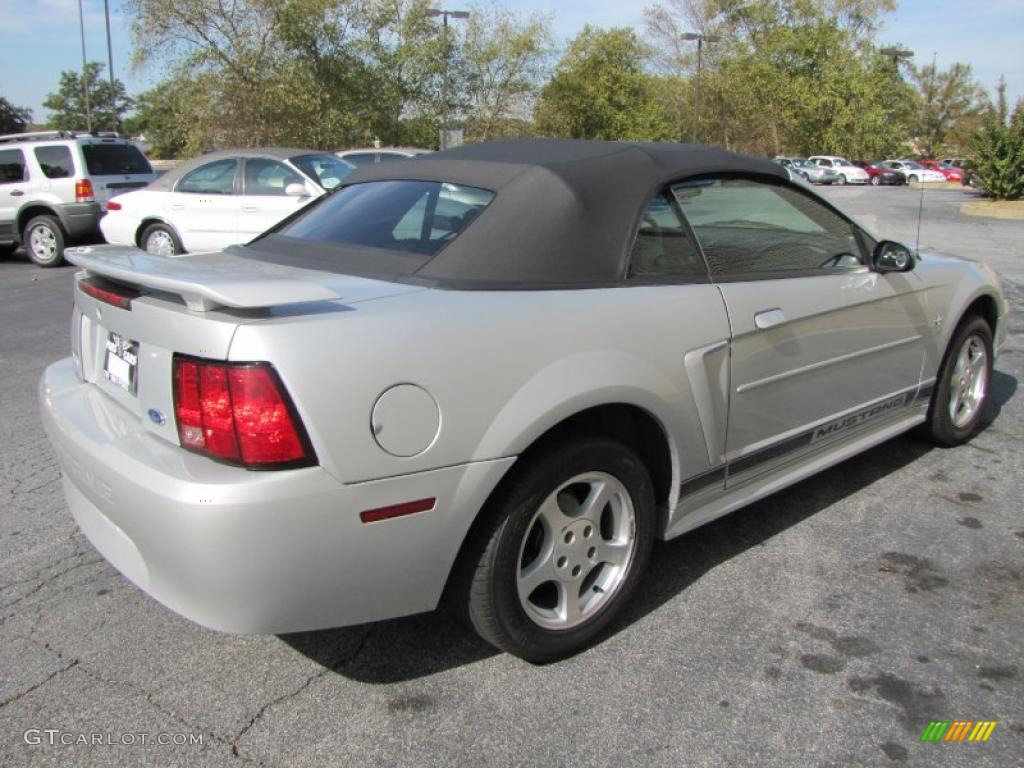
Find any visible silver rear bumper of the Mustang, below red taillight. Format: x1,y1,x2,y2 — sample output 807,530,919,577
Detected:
40,358,514,633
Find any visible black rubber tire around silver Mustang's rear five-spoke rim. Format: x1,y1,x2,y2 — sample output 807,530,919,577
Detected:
456,433,656,664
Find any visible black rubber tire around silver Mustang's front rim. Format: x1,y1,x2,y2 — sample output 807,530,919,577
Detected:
924,315,992,447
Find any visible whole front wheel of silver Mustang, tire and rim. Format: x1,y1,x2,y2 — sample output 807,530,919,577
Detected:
925,316,992,447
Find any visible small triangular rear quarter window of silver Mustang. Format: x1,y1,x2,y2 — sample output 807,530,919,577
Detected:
630,196,708,278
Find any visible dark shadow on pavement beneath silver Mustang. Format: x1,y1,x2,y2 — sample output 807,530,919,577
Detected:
280,371,1017,684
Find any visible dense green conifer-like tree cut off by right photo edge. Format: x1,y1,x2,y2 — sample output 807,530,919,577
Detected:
971,79,1024,200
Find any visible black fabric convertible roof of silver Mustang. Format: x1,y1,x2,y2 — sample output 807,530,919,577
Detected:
345,139,788,288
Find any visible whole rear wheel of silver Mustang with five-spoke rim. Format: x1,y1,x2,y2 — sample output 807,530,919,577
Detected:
459,434,655,664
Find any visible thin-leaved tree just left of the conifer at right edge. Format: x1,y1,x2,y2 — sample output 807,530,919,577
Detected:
912,62,988,158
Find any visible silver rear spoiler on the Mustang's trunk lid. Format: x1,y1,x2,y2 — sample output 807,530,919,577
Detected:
65,246,341,312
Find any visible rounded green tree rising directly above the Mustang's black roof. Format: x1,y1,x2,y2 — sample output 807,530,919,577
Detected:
535,26,677,141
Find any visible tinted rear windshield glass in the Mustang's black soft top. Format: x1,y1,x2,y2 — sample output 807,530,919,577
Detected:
275,181,495,256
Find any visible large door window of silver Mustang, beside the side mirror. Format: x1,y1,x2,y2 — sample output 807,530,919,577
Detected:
672,178,865,278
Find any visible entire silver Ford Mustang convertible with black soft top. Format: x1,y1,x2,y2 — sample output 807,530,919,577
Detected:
40,140,1007,662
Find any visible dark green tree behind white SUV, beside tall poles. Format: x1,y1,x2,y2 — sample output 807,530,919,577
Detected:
43,61,134,131
